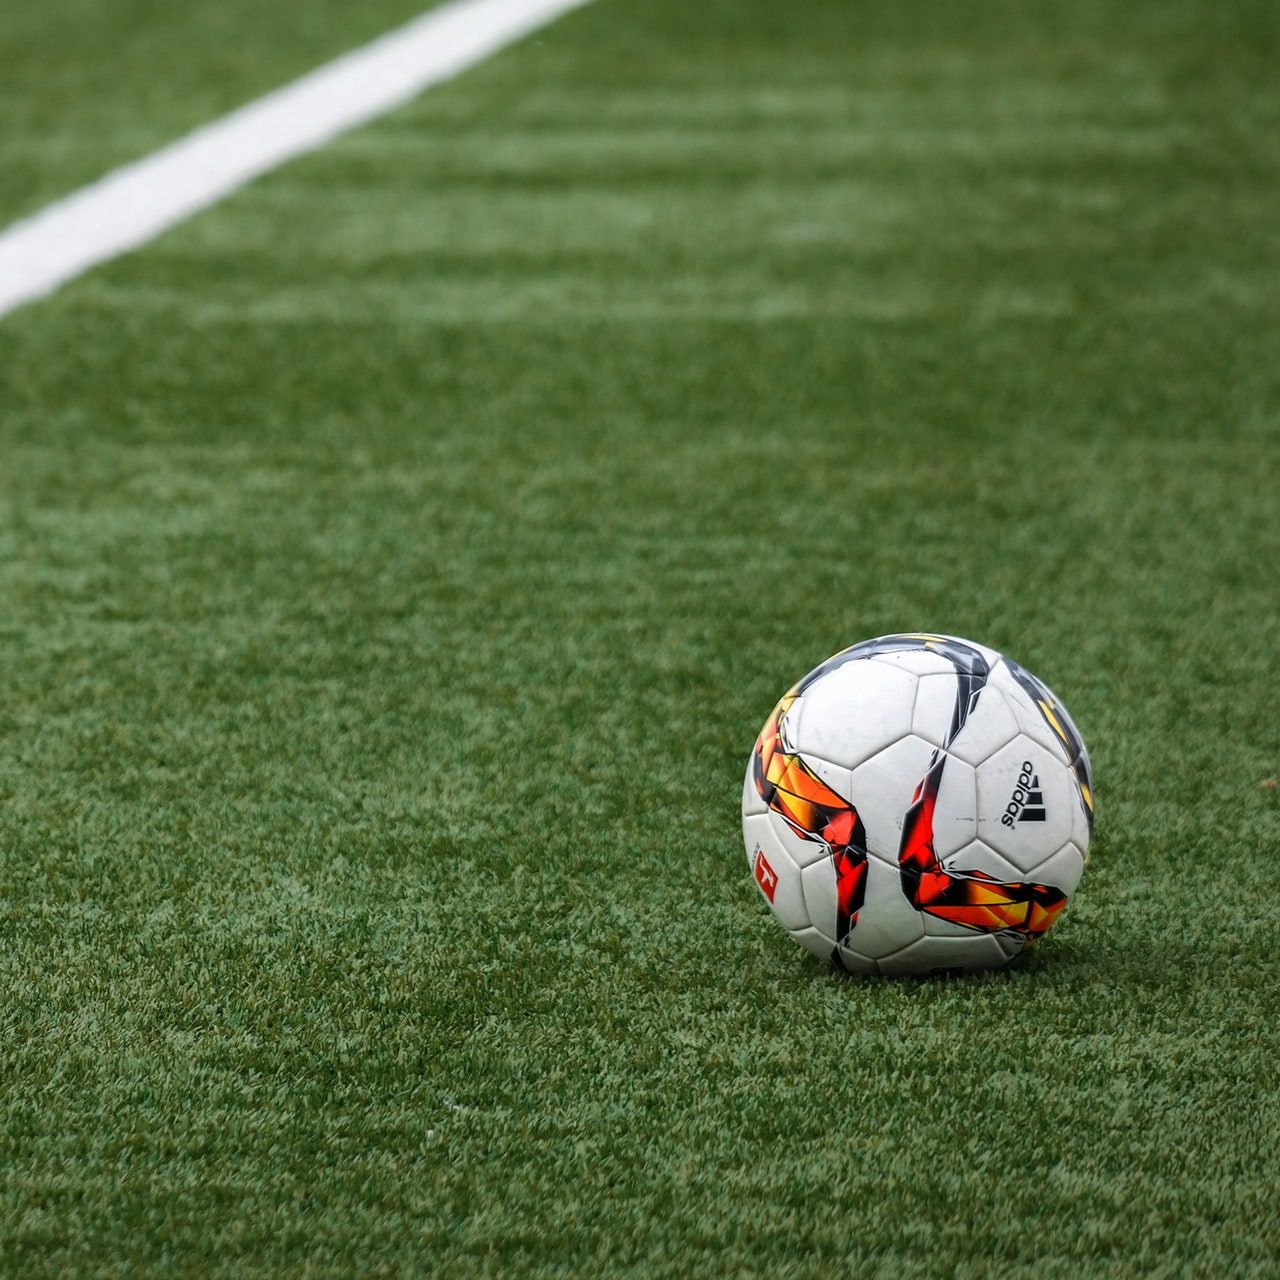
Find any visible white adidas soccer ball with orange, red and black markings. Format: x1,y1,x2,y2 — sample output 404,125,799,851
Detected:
742,634,1093,974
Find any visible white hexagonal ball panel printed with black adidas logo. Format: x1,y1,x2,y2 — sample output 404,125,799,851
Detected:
978,735,1079,873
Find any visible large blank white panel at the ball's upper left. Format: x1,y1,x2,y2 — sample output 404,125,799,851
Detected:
787,659,915,768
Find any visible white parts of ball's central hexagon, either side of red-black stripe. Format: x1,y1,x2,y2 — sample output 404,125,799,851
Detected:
849,735,978,867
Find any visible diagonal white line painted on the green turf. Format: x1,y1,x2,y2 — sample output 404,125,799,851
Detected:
0,0,586,316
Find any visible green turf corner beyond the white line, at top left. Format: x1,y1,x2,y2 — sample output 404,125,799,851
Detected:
0,0,429,225
